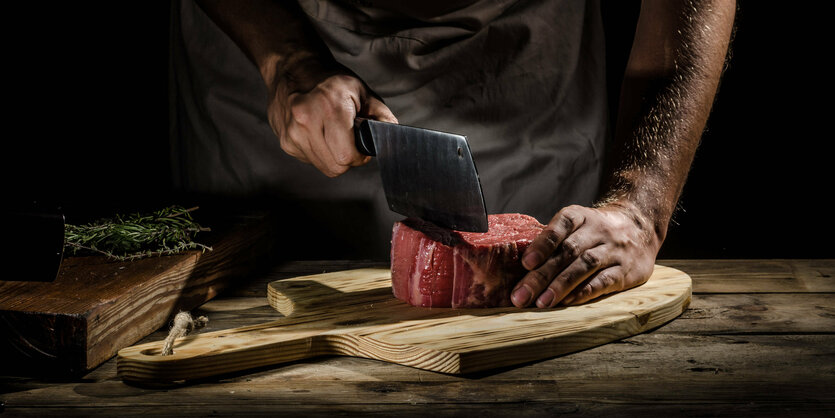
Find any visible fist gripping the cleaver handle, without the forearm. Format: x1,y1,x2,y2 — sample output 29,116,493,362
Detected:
267,75,397,177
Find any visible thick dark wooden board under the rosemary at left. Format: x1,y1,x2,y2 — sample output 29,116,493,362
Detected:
0,212,269,375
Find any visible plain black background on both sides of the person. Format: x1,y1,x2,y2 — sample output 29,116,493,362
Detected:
2,0,835,258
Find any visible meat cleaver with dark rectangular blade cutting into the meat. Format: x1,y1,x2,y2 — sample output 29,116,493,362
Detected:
354,118,487,232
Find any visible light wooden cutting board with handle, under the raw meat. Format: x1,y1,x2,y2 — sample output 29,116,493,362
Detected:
117,266,691,383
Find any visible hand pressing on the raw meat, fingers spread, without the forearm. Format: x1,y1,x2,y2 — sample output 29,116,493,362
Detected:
511,204,660,308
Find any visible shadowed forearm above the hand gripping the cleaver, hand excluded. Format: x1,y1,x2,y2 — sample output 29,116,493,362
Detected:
198,0,341,94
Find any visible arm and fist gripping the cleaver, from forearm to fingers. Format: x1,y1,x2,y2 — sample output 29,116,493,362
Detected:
194,0,397,177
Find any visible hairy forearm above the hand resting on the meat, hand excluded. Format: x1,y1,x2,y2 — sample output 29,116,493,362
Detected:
599,0,736,246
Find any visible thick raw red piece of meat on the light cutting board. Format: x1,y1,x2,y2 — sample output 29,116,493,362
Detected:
391,213,544,308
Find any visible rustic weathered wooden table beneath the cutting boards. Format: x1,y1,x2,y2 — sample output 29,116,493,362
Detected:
0,260,835,417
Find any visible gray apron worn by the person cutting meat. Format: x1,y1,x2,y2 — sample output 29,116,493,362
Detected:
171,0,608,258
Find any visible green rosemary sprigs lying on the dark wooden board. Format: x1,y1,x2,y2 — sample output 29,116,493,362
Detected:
64,206,212,261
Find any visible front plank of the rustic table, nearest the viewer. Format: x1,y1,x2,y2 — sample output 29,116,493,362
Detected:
4,334,835,416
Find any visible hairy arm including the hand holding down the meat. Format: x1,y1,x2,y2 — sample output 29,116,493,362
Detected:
511,0,736,307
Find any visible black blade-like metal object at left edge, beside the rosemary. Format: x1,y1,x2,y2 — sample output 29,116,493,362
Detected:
0,202,64,282
